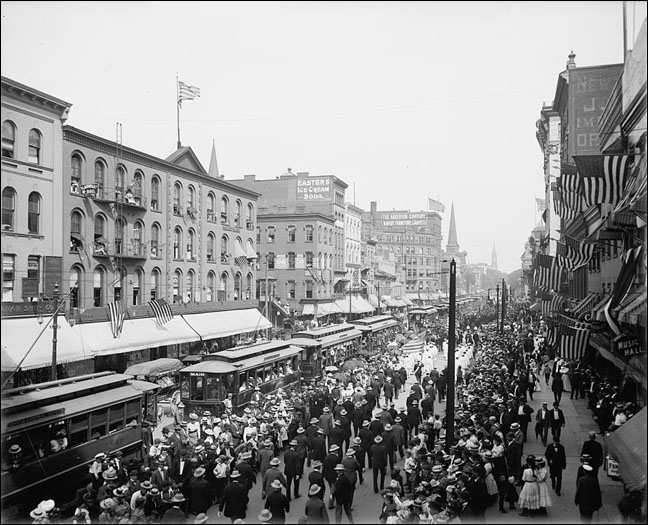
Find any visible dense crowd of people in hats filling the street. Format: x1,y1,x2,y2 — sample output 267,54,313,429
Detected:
17,300,632,523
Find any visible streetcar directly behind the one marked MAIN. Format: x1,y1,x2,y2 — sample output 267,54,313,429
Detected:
288,323,362,381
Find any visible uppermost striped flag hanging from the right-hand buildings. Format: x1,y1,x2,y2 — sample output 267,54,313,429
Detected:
574,155,634,206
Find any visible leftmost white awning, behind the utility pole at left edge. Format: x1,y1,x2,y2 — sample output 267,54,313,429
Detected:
1,315,94,371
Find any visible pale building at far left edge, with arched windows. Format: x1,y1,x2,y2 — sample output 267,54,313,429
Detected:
2,77,72,304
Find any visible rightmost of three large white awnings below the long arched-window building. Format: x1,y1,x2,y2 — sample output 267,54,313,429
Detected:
182,308,272,339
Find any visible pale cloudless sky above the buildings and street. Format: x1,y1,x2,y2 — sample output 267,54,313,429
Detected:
1,1,632,272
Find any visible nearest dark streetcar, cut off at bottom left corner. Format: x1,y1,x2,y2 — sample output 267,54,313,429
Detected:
0,372,159,517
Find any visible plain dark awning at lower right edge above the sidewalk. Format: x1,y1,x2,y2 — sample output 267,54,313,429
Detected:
605,407,648,490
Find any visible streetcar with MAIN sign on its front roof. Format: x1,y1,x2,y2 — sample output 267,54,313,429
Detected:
180,340,302,416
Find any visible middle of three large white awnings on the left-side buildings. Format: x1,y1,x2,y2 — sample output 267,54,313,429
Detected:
73,314,200,355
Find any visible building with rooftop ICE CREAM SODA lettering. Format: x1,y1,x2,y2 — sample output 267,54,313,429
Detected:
229,169,347,312
